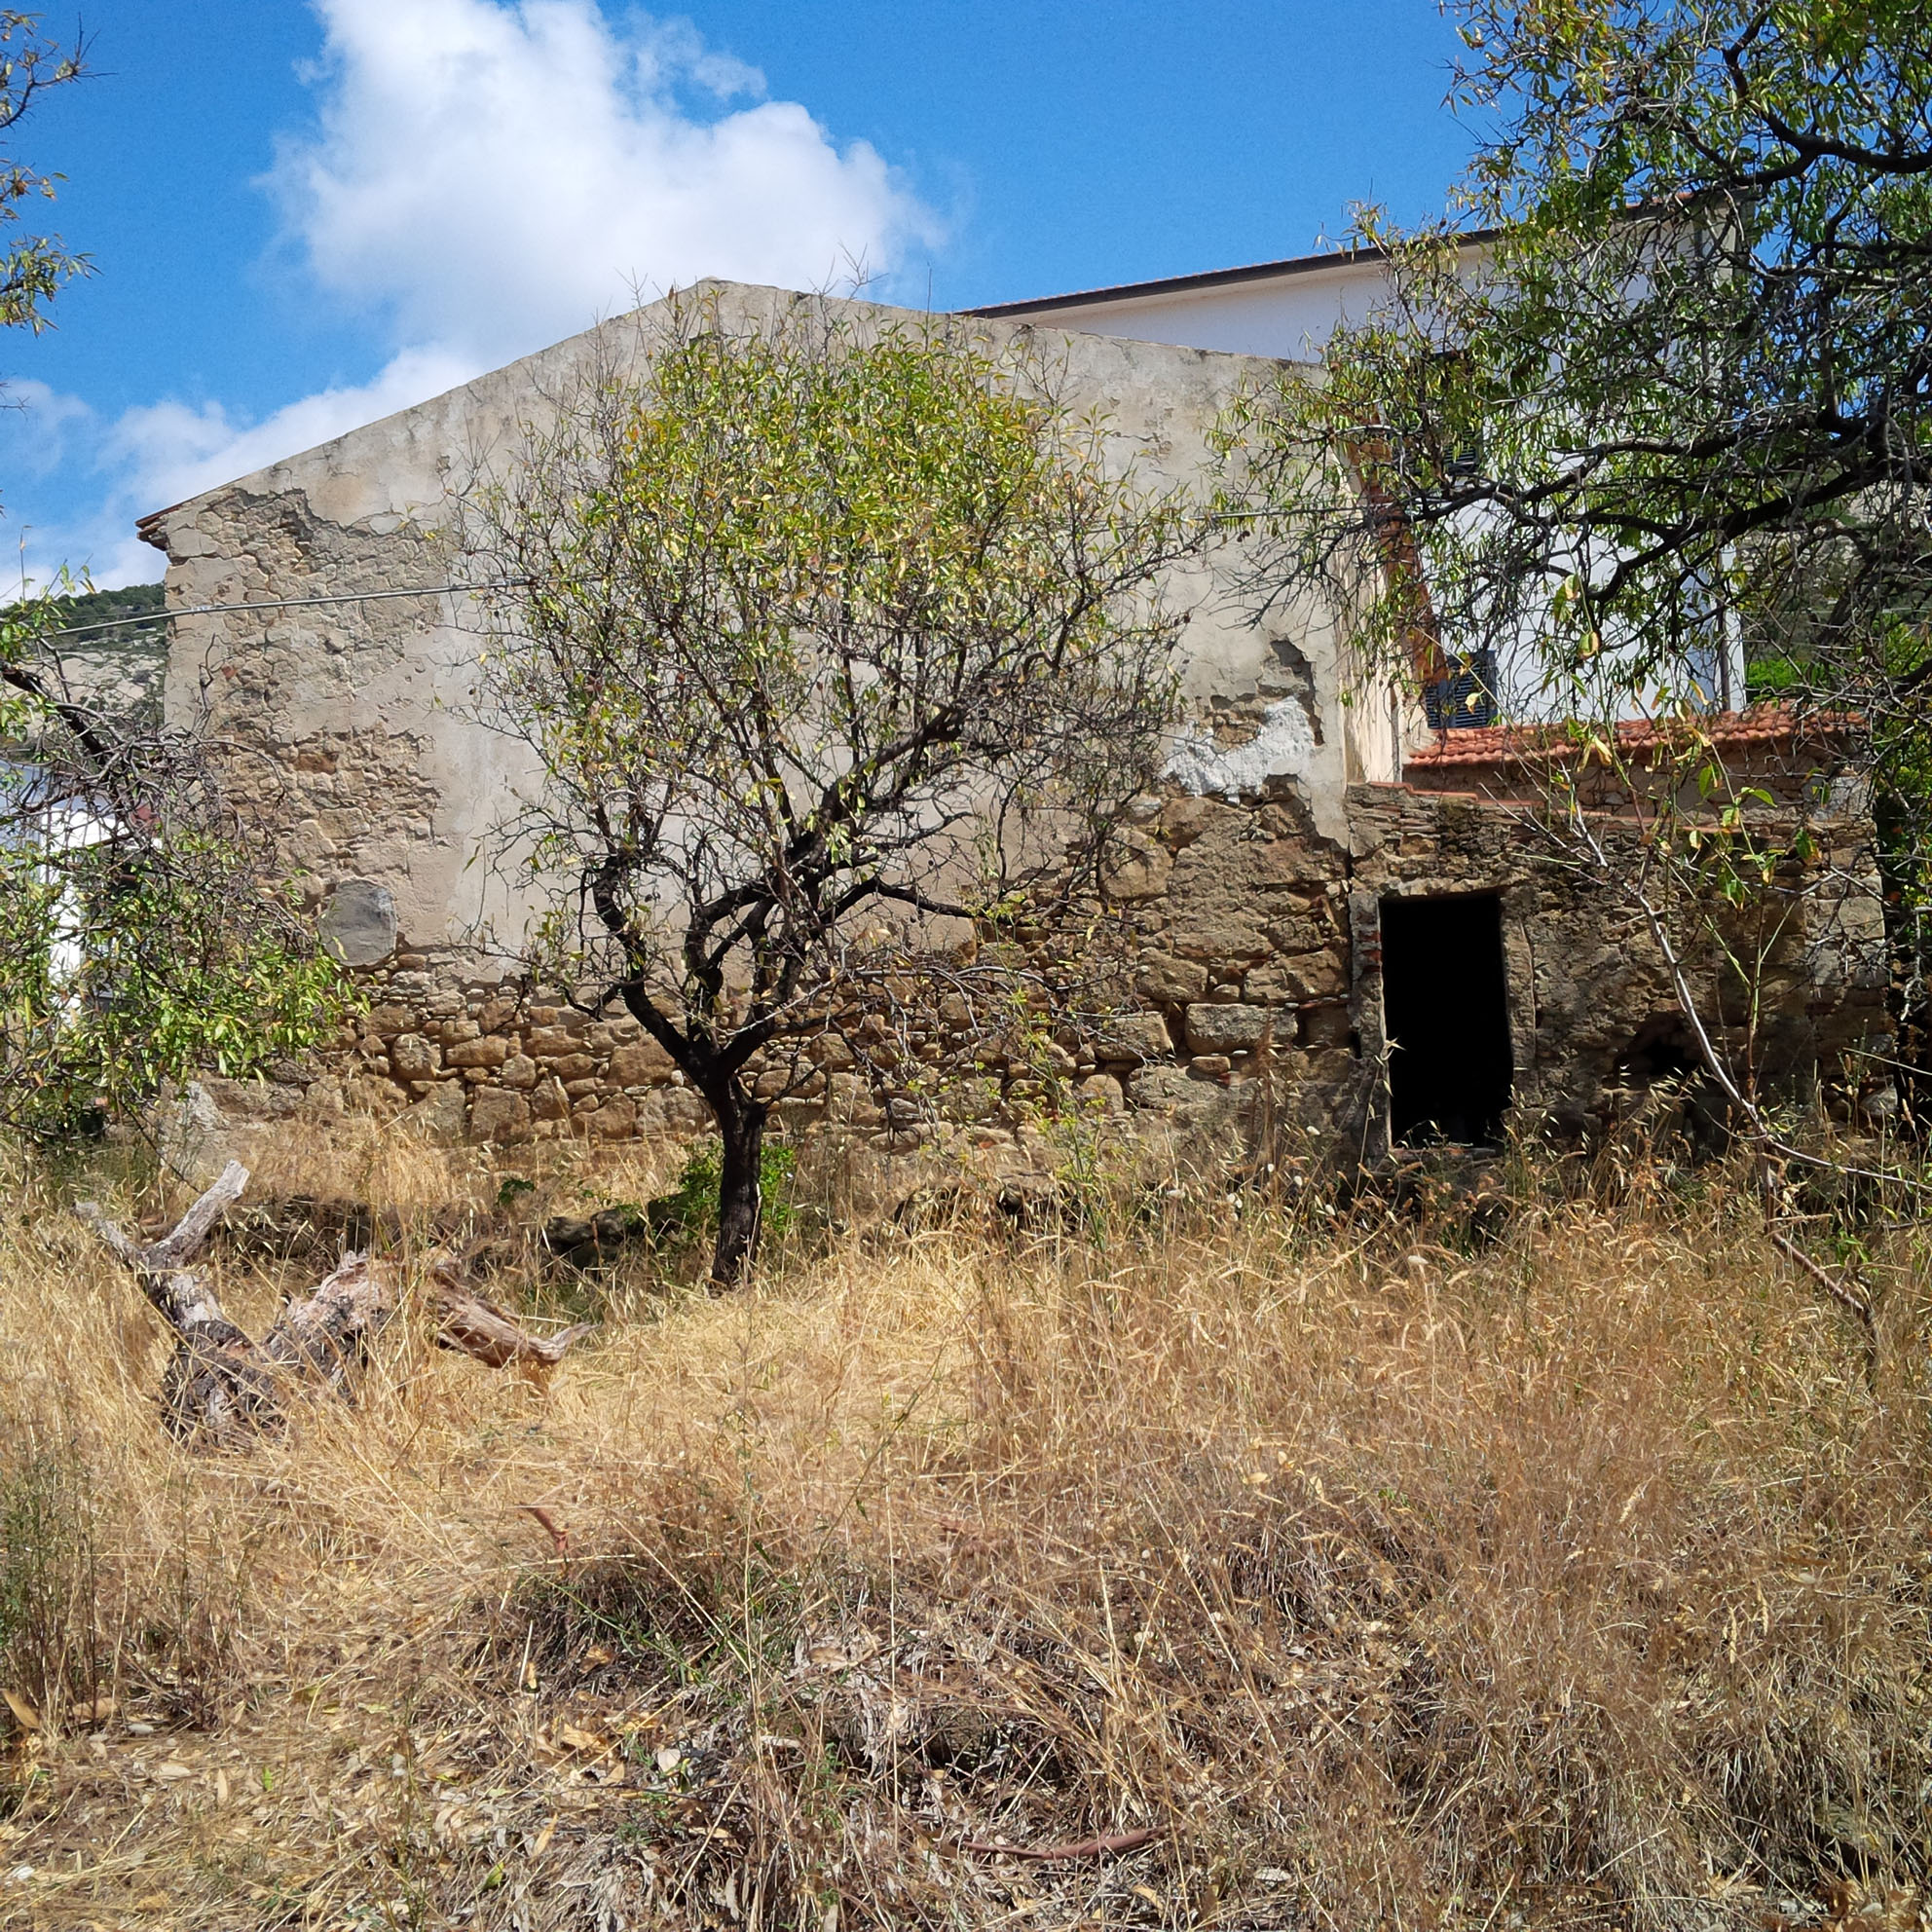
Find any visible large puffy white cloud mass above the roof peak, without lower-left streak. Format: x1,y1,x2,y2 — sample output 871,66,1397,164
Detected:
269,0,933,359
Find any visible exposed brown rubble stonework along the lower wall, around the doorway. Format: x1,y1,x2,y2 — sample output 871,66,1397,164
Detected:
200,764,1887,1159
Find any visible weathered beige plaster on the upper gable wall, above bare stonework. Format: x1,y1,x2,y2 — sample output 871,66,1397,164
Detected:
143,286,1345,970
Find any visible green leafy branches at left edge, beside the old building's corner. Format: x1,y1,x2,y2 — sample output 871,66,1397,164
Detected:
0,599,346,1134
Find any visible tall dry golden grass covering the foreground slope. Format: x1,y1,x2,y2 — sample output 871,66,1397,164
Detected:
0,1144,1932,1932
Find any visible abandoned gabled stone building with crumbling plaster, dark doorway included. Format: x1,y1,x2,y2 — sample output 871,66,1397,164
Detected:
141,253,1887,1157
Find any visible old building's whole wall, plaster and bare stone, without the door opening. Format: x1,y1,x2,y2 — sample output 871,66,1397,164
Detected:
143,286,1885,1153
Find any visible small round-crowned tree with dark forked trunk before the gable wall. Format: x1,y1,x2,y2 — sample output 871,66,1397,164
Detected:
467,302,1188,1281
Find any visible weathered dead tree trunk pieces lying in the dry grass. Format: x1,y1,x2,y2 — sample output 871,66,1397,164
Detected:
73,1161,591,1443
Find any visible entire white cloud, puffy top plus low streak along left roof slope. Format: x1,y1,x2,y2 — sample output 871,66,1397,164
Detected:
6,0,937,585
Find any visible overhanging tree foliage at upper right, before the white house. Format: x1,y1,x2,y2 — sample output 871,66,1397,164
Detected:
1227,0,1932,1128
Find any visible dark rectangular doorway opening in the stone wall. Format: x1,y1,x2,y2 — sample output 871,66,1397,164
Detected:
1382,893,1510,1146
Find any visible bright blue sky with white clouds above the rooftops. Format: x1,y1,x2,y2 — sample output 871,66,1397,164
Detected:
0,0,1468,583
